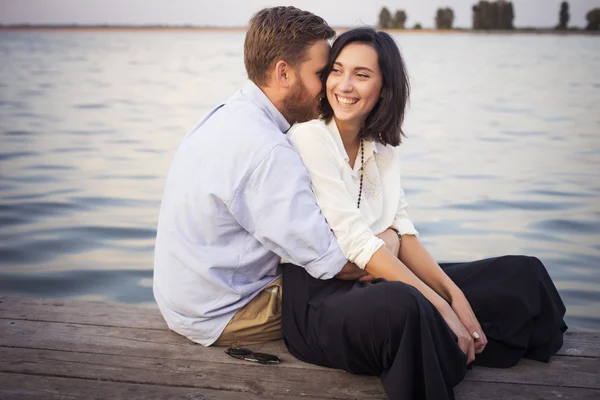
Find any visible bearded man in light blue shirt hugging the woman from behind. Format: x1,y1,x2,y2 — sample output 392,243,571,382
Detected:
154,7,366,346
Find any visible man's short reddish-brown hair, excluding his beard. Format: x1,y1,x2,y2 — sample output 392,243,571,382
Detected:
244,6,335,86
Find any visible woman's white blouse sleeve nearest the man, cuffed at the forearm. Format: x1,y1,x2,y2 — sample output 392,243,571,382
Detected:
288,124,385,269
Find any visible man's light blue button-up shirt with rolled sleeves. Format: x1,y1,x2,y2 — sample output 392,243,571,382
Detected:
153,82,346,346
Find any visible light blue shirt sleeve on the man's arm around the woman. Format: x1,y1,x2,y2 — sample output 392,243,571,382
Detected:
230,145,347,279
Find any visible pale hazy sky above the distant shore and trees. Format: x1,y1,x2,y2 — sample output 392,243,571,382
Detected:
0,0,600,28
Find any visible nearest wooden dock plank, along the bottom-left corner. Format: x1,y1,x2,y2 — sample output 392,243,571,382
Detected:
0,373,318,400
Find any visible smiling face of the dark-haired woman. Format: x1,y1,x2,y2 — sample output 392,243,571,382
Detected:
326,43,383,127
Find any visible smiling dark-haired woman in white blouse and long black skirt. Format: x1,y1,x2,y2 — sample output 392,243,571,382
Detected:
283,28,567,399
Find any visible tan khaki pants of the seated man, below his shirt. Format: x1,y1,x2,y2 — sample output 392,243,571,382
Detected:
213,278,282,347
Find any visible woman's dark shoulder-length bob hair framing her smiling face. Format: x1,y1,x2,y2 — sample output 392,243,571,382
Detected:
321,27,410,146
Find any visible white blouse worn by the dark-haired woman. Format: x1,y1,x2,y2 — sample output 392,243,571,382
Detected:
287,118,418,269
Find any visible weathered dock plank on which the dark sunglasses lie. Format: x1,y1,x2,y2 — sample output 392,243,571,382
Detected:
0,320,600,389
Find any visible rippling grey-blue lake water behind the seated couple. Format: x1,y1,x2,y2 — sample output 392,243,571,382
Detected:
0,30,600,331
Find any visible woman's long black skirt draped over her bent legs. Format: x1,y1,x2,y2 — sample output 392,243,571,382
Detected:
282,256,567,400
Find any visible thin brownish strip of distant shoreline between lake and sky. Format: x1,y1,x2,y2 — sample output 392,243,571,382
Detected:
0,25,600,35
